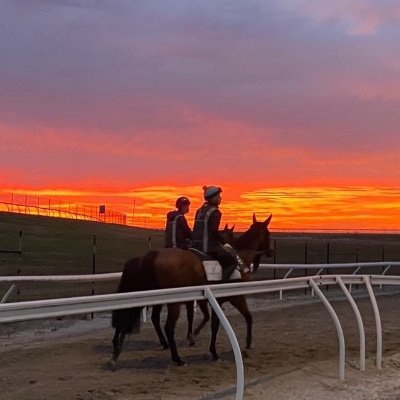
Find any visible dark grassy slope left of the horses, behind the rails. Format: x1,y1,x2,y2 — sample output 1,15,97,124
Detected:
0,213,163,300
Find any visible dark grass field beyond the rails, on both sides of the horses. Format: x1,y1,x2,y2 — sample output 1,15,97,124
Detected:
0,213,400,301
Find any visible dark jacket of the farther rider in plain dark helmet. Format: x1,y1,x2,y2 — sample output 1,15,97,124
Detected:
165,211,193,250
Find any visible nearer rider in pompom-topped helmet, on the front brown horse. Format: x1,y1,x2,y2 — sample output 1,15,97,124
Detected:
193,186,237,282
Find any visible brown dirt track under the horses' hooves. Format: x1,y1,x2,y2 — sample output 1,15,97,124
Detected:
0,290,400,400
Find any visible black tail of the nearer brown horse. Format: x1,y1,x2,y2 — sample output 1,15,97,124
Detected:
112,251,158,333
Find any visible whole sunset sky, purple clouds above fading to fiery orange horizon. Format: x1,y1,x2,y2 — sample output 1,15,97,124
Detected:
0,0,400,229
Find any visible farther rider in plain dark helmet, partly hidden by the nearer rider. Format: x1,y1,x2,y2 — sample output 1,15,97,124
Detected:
165,197,193,250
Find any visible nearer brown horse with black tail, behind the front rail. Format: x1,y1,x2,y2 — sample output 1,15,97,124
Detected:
111,215,272,369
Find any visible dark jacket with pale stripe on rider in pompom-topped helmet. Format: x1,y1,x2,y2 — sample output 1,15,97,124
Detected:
193,203,225,253
